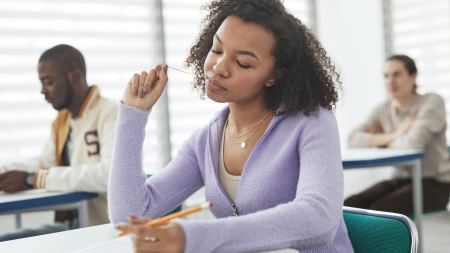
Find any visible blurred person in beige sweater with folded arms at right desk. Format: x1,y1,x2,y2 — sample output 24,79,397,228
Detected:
344,55,450,215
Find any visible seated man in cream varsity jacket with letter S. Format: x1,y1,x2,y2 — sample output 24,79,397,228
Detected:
0,45,117,233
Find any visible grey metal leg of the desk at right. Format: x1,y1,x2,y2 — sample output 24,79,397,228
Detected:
413,160,423,252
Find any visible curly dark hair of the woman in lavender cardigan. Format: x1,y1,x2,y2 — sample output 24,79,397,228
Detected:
186,0,341,115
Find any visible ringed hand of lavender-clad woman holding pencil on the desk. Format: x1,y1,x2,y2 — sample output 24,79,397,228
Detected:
120,216,185,253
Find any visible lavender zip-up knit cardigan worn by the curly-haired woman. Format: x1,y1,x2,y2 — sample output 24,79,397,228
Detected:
108,105,353,253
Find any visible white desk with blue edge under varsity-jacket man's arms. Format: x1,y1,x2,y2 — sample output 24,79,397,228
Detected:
0,190,97,228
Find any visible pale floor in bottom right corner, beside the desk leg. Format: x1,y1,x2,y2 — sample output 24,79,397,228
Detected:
423,212,450,253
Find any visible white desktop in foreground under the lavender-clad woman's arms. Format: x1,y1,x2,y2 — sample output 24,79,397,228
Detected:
0,224,297,253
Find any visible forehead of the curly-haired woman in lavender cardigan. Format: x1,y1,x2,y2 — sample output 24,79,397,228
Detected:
216,16,275,54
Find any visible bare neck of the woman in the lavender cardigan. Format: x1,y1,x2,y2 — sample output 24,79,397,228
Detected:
228,101,272,132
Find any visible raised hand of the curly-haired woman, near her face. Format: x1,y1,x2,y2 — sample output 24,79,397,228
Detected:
122,64,168,111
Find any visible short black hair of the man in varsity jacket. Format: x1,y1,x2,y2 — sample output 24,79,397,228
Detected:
39,44,86,79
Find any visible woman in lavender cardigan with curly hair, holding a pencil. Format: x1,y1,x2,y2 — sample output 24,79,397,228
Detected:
108,0,352,252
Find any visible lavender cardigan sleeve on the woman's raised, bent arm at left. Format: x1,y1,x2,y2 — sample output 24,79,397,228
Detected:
108,104,203,224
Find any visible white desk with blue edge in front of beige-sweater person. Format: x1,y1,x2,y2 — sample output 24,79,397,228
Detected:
342,148,424,252
